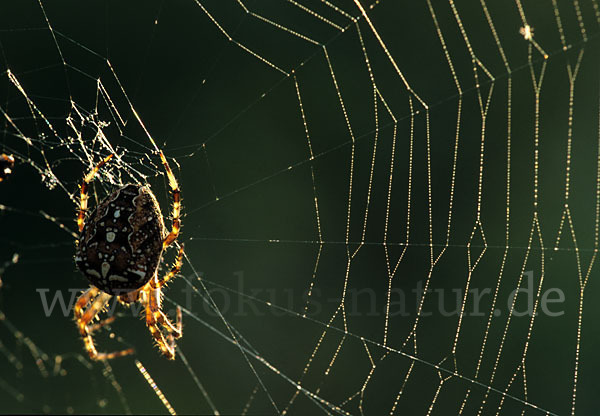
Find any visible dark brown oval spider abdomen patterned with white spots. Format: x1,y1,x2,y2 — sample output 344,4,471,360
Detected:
75,184,166,295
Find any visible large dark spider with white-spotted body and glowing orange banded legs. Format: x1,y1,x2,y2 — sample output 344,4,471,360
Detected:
73,151,183,360
